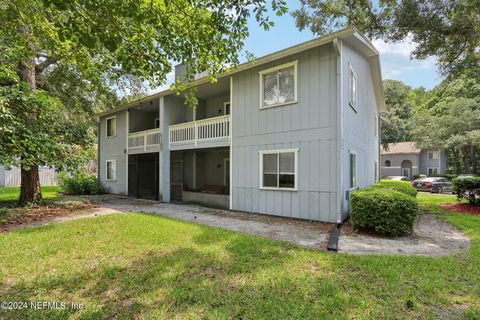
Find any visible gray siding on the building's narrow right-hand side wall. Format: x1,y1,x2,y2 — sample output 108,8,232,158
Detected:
341,43,380,218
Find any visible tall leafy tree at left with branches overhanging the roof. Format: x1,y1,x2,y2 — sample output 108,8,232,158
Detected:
0,0,286,202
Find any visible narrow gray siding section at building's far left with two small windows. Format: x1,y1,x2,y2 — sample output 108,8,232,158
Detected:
98,110,127,194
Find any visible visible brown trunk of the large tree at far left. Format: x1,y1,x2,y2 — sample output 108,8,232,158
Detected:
19,26,42,204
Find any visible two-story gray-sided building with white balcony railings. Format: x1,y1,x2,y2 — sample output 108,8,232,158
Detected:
98,28,385,222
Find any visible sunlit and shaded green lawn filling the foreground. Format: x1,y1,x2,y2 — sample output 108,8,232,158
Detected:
0,191,480,319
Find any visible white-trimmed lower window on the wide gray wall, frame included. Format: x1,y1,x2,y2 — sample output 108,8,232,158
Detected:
260,149,298,190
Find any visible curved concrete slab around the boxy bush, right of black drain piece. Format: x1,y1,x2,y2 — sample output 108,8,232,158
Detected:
338,213,470,257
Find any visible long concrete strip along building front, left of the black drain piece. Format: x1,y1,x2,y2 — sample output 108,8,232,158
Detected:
88,194,334,249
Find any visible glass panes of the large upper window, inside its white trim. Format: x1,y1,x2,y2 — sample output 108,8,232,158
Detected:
263,66,295,107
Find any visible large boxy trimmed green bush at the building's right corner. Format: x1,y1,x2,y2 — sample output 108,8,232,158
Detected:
350,187,418,236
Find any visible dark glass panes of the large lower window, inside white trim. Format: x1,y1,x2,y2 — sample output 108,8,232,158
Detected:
262,152,296,189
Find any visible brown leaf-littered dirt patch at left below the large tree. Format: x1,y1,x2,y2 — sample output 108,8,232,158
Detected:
0,200,98,232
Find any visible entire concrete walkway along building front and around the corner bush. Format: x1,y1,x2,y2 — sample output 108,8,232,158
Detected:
80,194,470,257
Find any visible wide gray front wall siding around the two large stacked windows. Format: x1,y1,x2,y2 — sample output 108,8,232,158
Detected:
231,45,337,222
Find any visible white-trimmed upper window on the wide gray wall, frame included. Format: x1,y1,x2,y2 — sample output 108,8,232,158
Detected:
260,61,297,109
